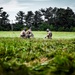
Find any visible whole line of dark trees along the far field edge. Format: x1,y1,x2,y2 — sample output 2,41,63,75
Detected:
0,7,75,31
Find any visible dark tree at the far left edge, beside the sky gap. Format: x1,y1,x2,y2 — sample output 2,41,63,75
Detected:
0,7,11,30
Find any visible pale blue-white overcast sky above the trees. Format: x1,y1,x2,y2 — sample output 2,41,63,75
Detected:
0,0,75,20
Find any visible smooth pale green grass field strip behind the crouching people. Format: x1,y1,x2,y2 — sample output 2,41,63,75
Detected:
0,31,75,39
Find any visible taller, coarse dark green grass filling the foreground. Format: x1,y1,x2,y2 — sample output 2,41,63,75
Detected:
0,38,75,75
